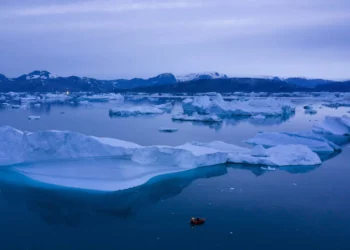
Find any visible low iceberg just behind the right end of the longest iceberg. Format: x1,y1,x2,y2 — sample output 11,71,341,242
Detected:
245,132,341,154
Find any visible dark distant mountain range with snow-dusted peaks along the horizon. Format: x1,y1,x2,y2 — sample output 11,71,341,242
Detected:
0,70,350,93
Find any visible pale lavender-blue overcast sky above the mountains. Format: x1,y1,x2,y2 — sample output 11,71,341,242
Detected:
0,0,350,79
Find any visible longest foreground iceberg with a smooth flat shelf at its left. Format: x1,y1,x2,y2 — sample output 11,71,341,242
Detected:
0,126,321,190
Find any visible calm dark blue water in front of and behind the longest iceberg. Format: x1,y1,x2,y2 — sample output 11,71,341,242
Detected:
0,100,350,250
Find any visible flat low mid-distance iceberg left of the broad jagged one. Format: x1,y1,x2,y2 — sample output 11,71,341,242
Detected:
109,106,164,117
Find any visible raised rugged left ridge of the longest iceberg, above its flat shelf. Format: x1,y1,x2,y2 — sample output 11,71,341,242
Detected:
0,126,140,165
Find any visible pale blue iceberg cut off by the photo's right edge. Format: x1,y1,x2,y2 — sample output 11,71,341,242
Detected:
313,115,350,136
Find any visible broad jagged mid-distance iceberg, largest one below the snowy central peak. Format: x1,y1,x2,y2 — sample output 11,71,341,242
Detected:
182,94,295,118
